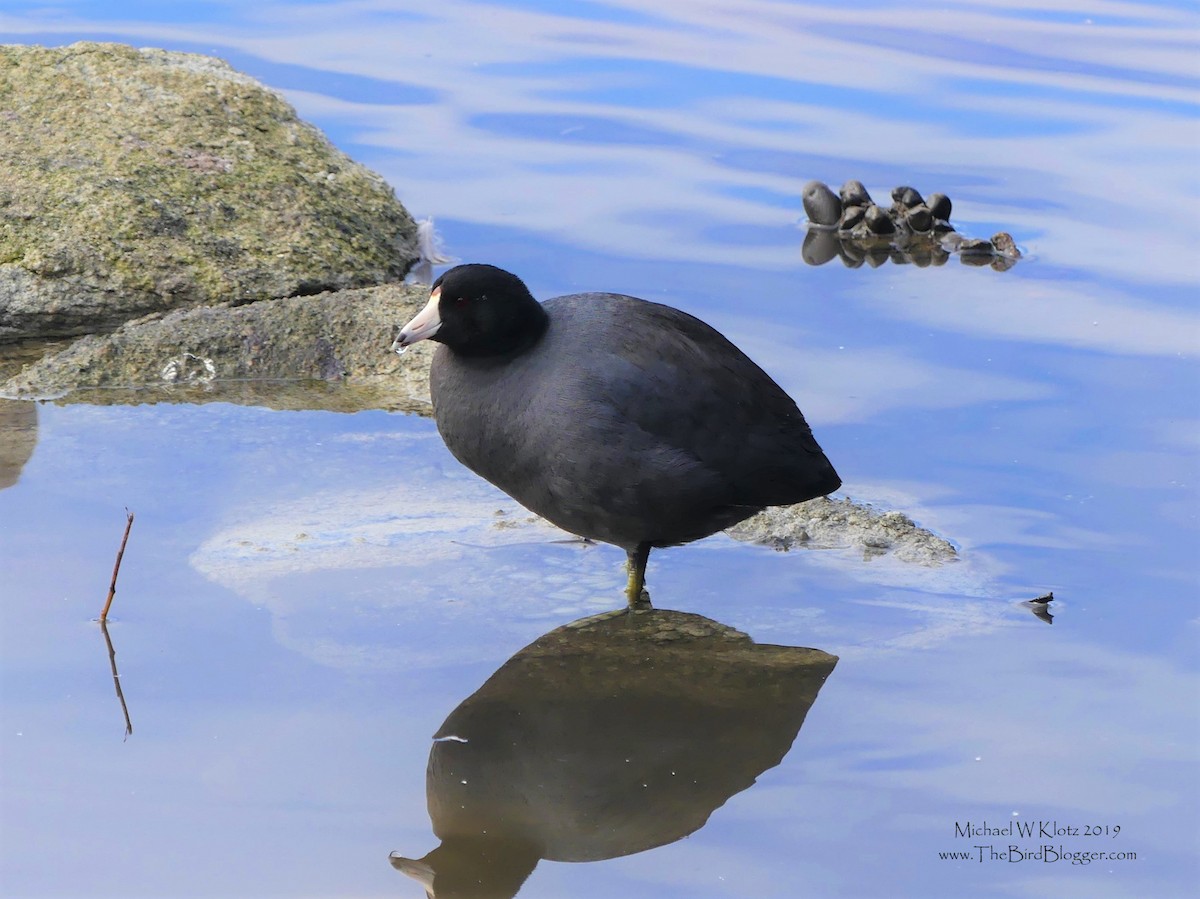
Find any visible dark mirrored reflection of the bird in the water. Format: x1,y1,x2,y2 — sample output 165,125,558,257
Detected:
392,610,838,899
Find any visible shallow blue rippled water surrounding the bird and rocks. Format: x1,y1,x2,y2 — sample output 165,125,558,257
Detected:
0,0,1200,897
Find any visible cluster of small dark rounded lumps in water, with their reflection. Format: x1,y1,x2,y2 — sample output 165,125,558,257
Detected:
802,181,1021,271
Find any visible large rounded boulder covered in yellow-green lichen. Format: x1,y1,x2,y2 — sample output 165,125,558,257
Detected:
0,43,416,341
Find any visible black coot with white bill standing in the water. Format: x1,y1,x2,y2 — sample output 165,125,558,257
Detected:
395,265,841,605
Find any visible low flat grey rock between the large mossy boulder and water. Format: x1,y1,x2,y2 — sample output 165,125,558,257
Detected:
0,284,432,410
